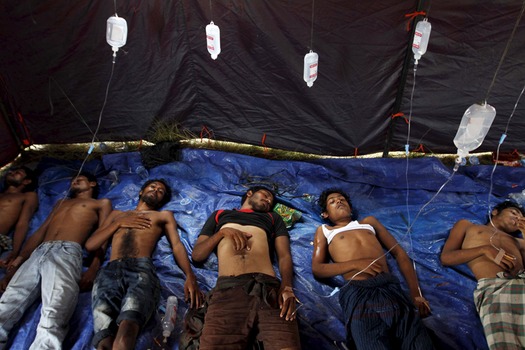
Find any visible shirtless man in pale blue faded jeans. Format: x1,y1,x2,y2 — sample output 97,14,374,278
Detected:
0,173,111,349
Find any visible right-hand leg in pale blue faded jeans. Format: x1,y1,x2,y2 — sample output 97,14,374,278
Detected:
30,242,82,350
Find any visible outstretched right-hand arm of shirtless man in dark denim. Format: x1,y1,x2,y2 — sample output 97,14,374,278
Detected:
162,210,203,308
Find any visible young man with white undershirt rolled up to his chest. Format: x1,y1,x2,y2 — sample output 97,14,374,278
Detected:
312,189,432,349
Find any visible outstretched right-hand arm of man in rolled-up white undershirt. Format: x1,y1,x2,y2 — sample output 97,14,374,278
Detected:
363,216,430,317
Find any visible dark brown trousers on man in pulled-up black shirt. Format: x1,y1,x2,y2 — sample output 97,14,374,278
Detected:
200,274,301,350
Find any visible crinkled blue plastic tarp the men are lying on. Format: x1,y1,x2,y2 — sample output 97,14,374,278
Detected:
4,149,525,349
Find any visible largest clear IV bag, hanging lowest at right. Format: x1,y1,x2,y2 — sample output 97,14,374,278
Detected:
454,102,496,164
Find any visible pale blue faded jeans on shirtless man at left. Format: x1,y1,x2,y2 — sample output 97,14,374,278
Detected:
0,241,82,350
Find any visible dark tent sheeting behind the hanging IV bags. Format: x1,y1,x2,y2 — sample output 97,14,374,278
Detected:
0,0,525,164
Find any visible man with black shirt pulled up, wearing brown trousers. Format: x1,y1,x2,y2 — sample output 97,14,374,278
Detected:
192,187,300,350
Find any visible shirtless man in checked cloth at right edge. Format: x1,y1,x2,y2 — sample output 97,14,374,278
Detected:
441,201,525,349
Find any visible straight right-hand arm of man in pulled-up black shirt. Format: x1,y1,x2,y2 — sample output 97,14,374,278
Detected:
275,236,296,321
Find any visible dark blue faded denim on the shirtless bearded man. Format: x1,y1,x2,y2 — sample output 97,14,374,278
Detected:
92,258,160,347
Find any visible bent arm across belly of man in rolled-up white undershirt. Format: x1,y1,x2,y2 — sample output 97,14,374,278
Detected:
312,226,382,278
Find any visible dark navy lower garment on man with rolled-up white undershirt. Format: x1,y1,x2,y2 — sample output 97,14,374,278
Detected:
339,273,433,350
